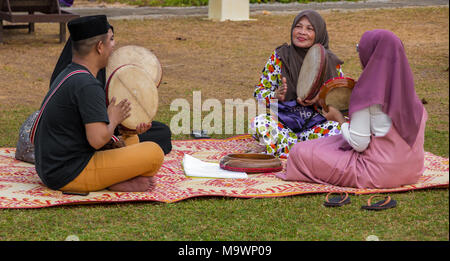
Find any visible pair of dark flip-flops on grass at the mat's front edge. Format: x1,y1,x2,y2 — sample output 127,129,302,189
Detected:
323,192,397,210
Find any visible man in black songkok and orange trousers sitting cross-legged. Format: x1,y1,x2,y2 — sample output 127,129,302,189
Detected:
32,15,164,192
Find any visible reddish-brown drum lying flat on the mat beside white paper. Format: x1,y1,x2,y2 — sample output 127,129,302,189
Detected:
219,153,283,173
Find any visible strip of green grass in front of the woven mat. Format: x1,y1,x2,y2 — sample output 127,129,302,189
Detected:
0,189,449,241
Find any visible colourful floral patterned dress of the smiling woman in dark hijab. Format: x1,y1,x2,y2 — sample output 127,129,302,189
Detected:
250,51,343,158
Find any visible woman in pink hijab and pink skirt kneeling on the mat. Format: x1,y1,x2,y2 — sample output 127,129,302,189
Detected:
277,30,428,188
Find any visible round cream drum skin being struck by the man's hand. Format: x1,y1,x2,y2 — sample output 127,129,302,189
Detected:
106,64,158,130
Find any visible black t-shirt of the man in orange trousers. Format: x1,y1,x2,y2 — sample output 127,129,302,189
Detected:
34,63,109,189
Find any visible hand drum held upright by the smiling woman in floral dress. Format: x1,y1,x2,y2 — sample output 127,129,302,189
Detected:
297,43,327,100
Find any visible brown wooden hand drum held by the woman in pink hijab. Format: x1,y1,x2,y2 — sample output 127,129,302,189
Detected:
319,77,355,114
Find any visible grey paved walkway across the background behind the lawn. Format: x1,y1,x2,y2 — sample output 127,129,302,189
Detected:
63,0,449,19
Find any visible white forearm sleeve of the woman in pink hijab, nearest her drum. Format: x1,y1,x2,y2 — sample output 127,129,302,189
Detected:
341,108,370,152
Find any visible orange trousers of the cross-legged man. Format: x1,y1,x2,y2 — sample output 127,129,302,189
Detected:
59,135,164,192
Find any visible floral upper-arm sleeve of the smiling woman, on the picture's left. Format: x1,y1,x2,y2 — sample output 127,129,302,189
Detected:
253,51,282,106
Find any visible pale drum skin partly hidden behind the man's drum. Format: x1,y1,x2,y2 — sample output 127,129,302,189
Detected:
106,45,162,88
